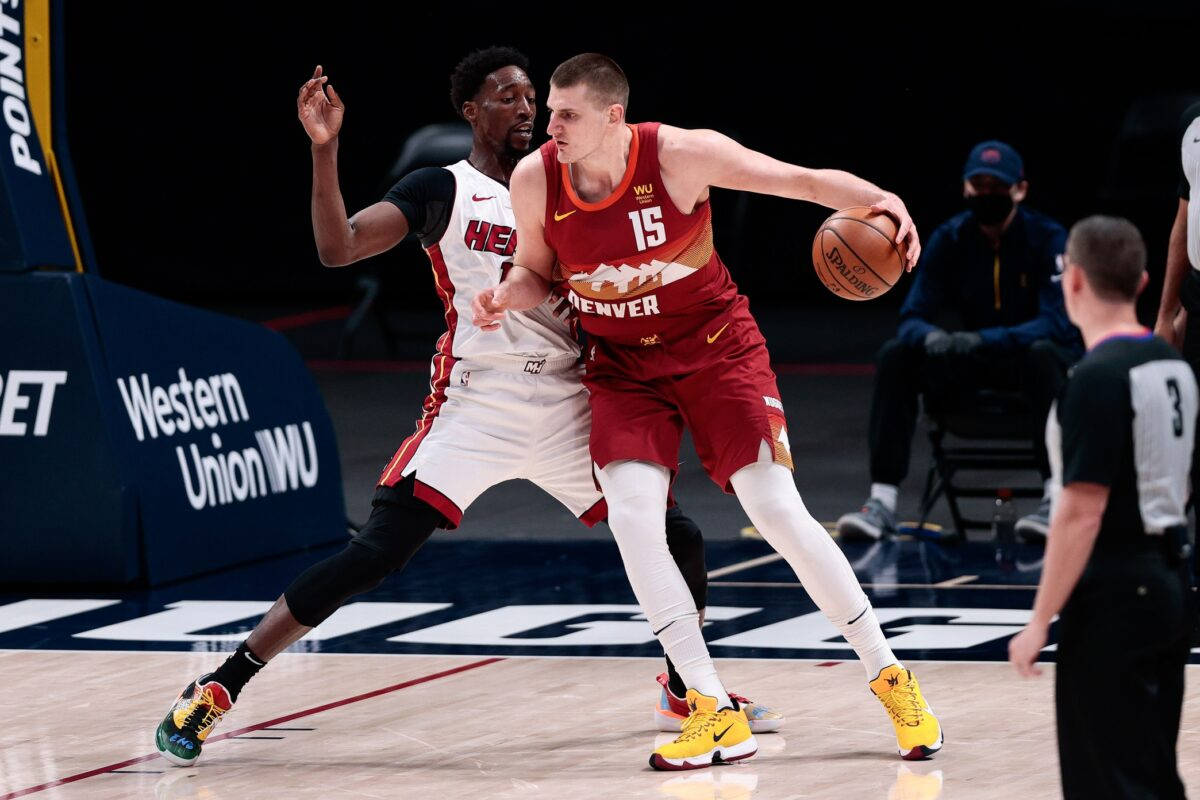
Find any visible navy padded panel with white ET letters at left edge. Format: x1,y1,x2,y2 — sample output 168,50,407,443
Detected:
0,273,139,583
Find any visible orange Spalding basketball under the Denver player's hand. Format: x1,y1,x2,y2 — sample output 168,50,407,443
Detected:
812,205,905,300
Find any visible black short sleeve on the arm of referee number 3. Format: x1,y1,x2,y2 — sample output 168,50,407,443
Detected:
1058,363,1133,486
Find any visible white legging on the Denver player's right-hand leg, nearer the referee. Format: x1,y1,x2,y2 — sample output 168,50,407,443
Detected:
730,445,896,679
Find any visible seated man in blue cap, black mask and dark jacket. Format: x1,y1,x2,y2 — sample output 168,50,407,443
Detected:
838,142,1082,539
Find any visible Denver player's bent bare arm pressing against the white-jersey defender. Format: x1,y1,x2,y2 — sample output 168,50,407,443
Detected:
470,152,554,331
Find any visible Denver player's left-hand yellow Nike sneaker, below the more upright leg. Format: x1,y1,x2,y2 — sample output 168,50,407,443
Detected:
650,688,758,770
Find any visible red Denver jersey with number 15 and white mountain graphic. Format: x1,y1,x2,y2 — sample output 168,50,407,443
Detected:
541,122,744,345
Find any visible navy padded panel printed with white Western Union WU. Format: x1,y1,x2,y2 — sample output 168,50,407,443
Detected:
80,276,346,584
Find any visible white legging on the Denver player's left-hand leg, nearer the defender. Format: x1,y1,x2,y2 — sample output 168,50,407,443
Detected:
596,461,733,709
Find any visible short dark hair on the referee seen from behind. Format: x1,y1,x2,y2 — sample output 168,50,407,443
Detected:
1067,215,1146,302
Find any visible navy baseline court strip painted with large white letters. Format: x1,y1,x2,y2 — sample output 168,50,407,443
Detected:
0,535,1200,662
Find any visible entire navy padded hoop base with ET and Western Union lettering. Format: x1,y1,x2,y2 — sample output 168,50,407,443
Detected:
0,272,346,585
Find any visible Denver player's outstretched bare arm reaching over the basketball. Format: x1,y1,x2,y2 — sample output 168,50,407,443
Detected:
659,125,920,270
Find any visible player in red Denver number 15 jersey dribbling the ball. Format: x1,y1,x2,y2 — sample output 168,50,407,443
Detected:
472,54,942,769
